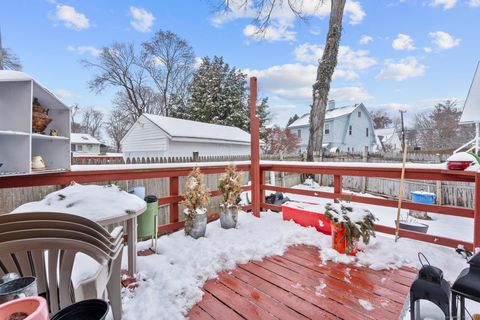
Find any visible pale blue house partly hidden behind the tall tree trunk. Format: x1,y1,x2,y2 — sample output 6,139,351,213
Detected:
288,101,376,152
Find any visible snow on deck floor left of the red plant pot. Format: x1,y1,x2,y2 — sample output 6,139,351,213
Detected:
123,212,330,319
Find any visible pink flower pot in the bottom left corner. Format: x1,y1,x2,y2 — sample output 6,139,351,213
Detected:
0,297,48,320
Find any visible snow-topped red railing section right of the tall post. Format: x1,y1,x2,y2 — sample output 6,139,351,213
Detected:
260,161,480,250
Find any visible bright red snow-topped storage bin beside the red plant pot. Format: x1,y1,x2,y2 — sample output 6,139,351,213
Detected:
282,204,332,235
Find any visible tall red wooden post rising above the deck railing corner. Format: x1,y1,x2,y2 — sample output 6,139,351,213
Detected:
250,77,261,217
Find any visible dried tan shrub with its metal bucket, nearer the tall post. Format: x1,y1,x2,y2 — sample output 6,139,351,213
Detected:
218,165,246,229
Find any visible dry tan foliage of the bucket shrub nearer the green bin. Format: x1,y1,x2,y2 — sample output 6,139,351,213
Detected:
181,168,210,234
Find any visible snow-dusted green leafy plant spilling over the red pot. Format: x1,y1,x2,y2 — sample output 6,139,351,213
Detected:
325,201,378,251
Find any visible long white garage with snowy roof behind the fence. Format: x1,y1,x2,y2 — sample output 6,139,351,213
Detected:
121,114,250,159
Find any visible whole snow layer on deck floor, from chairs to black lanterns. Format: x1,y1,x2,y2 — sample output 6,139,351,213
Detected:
119,212,467,320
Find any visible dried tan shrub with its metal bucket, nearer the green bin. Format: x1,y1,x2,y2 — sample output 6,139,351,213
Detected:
181,168,210,239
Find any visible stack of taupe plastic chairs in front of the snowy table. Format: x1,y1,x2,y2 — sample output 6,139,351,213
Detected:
0,212,123,319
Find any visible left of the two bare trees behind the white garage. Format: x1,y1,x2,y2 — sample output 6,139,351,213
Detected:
82,43,157,120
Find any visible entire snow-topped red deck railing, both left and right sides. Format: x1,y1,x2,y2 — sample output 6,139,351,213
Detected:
0,161,480,250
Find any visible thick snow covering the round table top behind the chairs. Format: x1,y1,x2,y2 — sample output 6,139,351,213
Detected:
13,183,146,221
